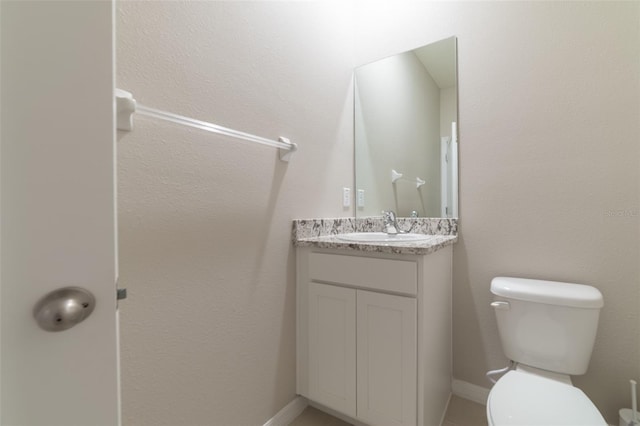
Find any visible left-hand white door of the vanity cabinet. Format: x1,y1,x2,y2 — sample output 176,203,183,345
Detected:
309,283,356,417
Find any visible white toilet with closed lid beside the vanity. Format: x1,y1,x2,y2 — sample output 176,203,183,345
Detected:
487,277,607,426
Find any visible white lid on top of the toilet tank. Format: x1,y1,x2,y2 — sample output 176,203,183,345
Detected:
491,277,604,308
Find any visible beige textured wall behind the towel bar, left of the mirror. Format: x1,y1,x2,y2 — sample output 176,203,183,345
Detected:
117,2,353,426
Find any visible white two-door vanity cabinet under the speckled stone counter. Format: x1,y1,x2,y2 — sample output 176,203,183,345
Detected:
297,246,451,426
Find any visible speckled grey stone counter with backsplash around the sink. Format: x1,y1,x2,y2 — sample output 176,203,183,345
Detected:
292,217,458,255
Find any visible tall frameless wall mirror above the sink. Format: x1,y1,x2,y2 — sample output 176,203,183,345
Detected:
354,37,458,217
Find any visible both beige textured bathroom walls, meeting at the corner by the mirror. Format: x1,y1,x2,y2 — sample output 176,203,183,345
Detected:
118,2,640,425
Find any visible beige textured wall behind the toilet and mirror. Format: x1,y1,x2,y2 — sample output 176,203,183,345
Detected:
355,2,640,423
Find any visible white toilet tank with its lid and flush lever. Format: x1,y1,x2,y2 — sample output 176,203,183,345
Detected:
491,277,604,375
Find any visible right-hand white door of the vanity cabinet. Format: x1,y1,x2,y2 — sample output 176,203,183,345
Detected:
357,290,417,426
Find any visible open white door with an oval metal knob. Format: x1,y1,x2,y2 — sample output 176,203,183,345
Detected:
0,1,119,426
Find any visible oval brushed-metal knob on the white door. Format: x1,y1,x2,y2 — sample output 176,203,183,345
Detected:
33,287,96,331
